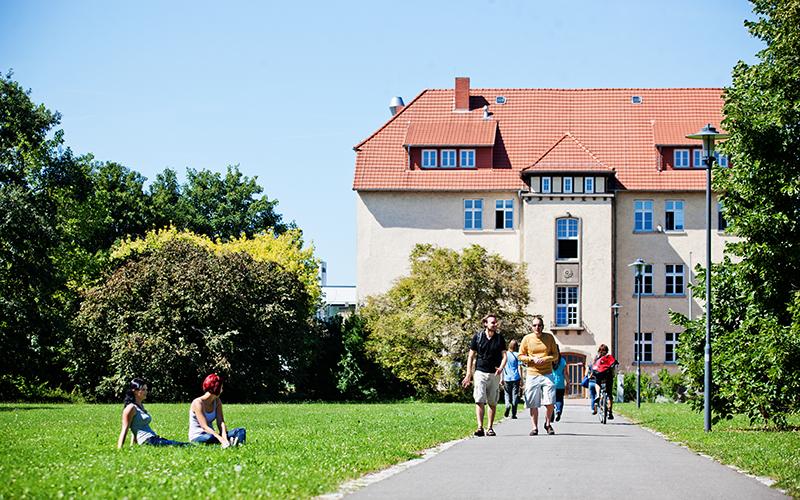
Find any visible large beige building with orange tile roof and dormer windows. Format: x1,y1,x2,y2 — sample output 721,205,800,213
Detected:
353,78,729,392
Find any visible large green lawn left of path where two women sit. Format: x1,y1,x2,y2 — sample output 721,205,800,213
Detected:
0,403,475,499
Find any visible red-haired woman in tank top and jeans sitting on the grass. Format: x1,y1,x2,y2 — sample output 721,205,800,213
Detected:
189,373,246,448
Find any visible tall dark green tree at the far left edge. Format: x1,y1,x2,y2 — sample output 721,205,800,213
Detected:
0,73,72,390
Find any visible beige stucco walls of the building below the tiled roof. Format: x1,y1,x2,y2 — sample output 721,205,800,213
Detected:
356,191,731,373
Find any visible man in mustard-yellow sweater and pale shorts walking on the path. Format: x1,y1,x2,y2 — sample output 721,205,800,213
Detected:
519,316,558,436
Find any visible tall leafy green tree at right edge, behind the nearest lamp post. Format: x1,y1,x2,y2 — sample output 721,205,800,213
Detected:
675,0,800,426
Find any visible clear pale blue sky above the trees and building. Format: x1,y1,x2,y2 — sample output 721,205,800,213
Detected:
0,0,761,284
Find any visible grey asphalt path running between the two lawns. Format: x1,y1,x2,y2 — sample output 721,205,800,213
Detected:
346,401,787,500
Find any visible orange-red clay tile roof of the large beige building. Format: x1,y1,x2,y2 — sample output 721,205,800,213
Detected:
353,88,722,191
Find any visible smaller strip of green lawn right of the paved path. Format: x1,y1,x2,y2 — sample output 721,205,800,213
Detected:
614,403,800,498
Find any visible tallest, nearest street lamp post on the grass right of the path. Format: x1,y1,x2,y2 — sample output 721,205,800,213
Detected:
686,123,728,432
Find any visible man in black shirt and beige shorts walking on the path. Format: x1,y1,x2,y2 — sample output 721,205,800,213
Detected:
461,314,506,436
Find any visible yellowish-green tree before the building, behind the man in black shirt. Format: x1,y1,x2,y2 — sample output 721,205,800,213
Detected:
361,245,528,398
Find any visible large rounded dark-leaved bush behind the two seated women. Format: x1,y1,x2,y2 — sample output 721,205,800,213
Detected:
67,239,311,401
